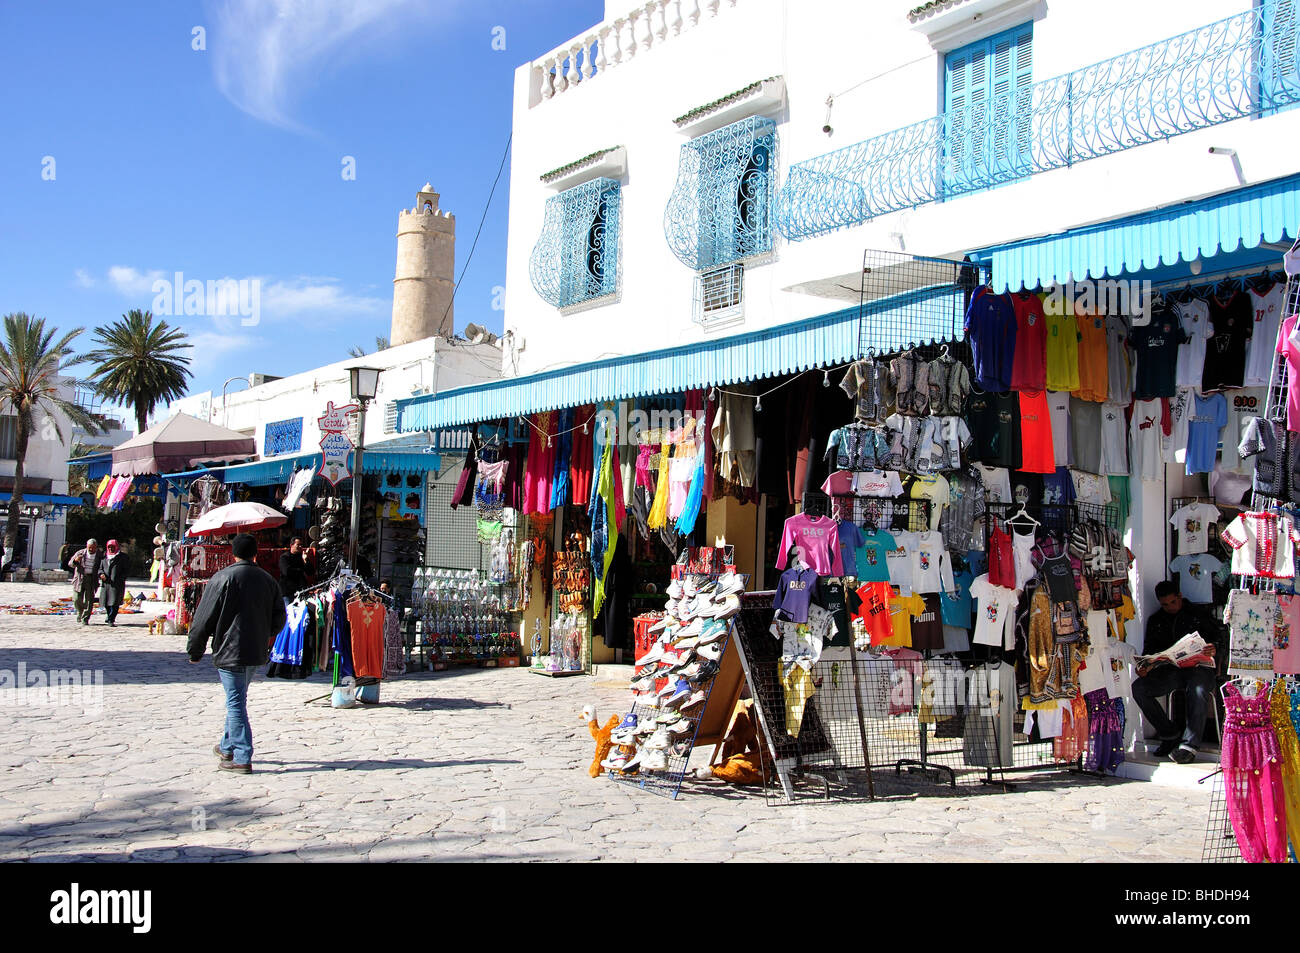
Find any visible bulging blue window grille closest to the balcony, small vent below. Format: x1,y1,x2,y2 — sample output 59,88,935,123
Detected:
663,116,776,272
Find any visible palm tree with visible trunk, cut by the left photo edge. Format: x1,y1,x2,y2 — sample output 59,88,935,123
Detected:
0,311,105,564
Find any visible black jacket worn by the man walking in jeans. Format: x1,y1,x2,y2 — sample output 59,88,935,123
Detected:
187,562,285,668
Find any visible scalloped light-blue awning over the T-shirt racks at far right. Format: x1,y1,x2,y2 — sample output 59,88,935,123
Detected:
971,176,1300,291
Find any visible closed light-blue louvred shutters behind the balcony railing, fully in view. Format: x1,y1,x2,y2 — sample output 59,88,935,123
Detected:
943,23,1034,192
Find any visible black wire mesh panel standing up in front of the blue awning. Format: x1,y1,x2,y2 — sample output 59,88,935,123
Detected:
858,248,980,354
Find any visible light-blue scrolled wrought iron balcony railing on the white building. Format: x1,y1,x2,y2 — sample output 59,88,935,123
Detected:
776,0,1300,241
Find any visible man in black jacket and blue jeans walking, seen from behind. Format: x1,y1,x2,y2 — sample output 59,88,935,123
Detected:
187,533,285,774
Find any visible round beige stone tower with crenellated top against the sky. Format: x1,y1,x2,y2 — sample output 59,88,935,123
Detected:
389,182,456,347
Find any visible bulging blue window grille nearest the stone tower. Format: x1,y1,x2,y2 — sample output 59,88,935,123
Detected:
529,178,621,308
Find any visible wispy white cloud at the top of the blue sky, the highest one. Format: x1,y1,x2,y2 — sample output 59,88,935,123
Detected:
208,0,447,131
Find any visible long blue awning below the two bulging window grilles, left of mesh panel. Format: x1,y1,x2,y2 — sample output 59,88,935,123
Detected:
397,307,861,433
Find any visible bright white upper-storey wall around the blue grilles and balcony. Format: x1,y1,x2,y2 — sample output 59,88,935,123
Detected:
504,0,1300,374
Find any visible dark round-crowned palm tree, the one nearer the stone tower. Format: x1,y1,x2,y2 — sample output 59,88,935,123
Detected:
83,308,191,433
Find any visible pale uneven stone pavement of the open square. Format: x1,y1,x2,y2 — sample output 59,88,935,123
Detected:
0,585,1209,861
